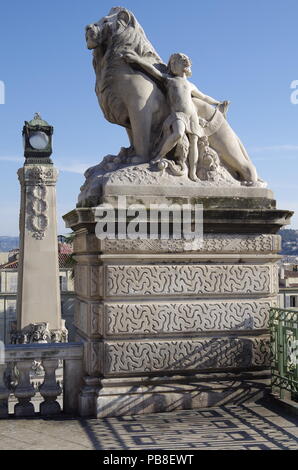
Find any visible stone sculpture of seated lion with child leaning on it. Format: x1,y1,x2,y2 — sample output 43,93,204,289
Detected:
81,7,264,200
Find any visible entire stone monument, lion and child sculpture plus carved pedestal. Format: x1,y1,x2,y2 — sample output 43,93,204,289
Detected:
60,7,291,417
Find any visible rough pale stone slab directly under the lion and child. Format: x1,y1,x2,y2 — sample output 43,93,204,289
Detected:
78,163,273,206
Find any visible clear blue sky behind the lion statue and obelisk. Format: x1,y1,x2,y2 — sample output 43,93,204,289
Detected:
0,0,298,235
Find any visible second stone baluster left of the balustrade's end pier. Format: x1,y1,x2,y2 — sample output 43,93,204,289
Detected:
14,359,36,416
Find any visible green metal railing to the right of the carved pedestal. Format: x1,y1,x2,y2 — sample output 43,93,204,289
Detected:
269,308,298,401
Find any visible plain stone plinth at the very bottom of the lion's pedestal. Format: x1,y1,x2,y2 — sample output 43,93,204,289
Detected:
92,370,270,418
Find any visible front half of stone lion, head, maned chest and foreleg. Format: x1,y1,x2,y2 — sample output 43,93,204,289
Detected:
86,7,168,162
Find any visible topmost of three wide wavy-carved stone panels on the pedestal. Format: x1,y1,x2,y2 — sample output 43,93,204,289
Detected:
106,264,272,296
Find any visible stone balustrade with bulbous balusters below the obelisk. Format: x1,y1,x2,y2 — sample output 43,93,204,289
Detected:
0,343,83,418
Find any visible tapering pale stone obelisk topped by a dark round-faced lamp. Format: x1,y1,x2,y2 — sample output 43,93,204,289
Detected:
12,114,67,343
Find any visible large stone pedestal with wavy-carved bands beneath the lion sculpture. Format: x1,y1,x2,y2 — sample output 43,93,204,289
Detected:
65,178,292,417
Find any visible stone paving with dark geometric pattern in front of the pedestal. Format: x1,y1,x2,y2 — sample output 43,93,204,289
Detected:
0,402,298,450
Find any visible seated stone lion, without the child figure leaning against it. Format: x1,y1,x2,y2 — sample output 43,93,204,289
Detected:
86,7,258,184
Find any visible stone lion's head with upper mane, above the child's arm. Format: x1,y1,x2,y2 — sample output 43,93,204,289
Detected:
86,7,162,63
